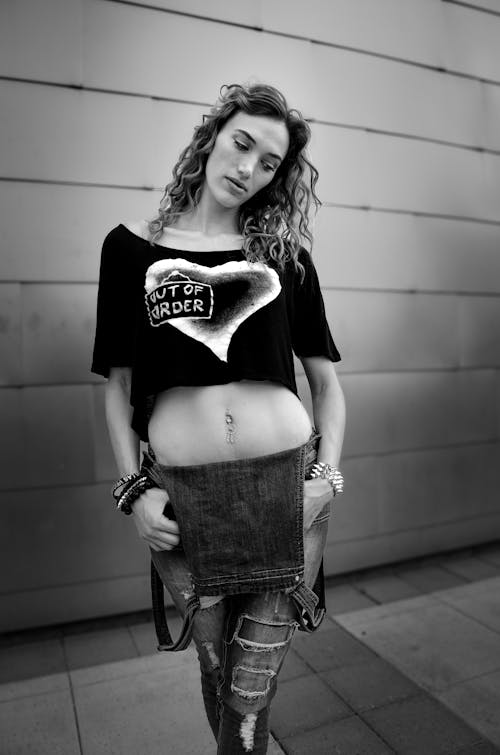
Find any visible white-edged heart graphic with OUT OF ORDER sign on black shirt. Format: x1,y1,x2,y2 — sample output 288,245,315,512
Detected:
144,258,281,362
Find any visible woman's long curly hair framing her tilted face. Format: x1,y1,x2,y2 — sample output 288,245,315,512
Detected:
149,84,321,275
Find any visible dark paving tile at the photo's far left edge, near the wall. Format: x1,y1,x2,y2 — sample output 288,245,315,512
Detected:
0,639,66,684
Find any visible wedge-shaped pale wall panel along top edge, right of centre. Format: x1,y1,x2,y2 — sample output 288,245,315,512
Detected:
263,0,442,66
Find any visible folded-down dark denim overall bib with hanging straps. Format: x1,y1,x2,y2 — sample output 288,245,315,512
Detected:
141,431,329,650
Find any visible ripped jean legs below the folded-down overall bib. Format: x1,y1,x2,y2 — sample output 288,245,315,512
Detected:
151,438,330,755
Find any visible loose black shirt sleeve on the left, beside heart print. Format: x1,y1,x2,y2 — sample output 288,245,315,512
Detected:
91,228,136,377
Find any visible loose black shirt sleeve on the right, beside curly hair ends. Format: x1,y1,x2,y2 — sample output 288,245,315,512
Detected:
292,249,340,362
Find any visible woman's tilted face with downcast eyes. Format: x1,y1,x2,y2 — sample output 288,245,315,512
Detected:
203,110,289,209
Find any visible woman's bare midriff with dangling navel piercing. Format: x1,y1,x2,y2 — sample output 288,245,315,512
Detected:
148,380,312,466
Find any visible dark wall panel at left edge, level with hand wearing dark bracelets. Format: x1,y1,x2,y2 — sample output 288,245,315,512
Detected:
0,484,149,591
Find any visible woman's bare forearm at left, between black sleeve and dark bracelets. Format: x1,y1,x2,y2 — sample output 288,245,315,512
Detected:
105,376,140,475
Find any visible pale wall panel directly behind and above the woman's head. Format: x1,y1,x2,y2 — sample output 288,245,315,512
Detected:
84,0,313,113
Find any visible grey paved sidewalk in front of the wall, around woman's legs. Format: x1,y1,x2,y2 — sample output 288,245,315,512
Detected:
0,544,500,755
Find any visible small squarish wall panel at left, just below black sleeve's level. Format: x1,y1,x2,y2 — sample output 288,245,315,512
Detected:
22,284,97,384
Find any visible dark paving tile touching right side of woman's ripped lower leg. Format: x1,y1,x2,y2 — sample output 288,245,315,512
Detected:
271,675,352,740
